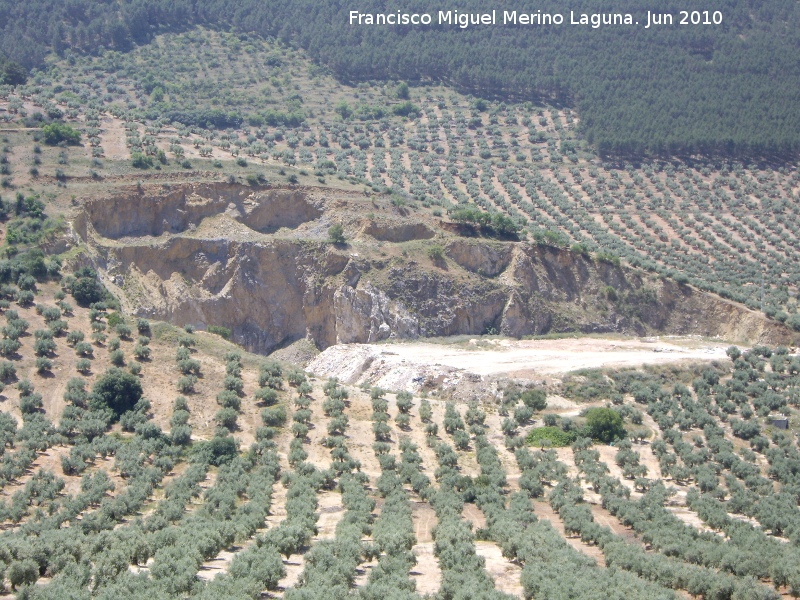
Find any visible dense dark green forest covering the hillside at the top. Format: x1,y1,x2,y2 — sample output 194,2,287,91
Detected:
0,0,800,161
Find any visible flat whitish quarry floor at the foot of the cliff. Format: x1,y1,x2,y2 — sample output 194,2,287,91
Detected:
307,336,730,392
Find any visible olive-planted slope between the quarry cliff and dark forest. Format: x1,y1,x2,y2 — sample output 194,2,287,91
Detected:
3,30,800,326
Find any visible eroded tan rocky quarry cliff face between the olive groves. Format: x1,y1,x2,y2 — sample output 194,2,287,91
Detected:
74,185,790,352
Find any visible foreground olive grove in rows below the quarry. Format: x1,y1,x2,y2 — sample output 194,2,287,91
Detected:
0,275,800,598
